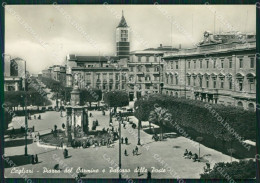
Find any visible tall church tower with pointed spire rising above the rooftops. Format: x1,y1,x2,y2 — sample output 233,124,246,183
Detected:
116,11,130,59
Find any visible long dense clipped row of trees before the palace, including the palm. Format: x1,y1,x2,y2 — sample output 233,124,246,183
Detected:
134,95,256,158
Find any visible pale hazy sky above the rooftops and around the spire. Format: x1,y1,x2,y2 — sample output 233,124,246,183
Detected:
5,4,256,73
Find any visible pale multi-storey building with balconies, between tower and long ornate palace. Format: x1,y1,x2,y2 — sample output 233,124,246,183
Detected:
127,45,177,100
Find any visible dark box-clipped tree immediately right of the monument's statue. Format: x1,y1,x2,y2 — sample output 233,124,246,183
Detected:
80,88,102,107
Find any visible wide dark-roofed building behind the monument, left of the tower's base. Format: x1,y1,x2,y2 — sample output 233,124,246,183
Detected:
66,55,128,92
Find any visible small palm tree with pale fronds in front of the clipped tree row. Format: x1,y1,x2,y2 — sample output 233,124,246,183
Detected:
149,107,171,140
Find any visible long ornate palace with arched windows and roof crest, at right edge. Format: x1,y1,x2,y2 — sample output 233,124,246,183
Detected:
163,31,256,110
